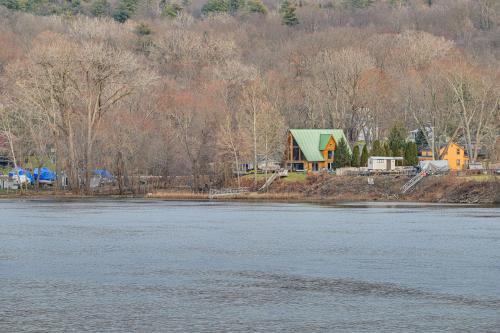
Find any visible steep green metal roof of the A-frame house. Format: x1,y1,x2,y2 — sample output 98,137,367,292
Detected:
290,129,350,162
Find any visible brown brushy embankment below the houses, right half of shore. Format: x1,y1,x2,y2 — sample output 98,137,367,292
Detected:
243,175,500,204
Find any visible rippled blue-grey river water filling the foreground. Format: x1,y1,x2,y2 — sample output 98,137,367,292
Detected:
0,200,500,332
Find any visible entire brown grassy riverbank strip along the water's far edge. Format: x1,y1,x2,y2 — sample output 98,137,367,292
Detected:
0,175,500,205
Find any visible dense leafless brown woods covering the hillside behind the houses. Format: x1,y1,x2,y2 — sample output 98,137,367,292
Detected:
0,0,500,191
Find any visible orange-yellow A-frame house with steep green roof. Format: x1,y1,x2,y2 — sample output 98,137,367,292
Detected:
285,129,347,171
